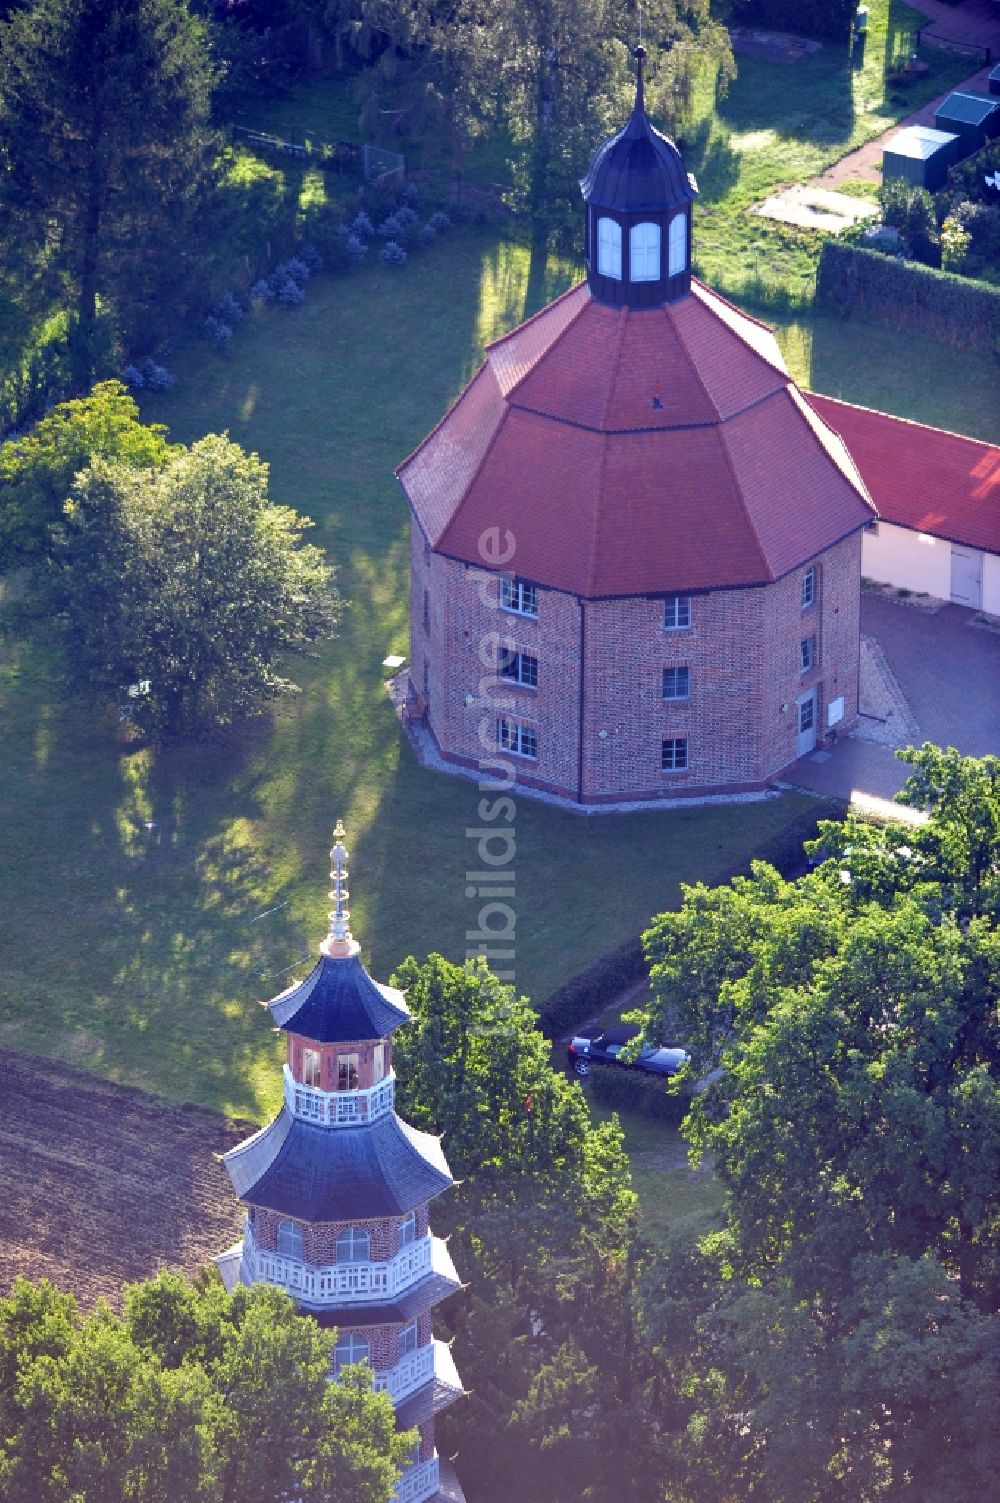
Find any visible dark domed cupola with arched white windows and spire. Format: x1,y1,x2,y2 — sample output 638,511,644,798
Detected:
580,47,698,308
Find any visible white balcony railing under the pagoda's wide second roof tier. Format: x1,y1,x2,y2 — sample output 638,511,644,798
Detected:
244,1222,433,1306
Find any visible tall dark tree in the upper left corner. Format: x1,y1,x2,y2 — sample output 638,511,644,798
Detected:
0,0,212,388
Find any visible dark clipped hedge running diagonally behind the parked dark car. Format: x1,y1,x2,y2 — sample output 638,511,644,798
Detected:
538,803,842,1039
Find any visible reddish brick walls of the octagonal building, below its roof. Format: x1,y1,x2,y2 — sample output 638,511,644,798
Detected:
411,522,860,803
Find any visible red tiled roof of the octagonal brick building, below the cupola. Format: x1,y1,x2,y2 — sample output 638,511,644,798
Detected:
397,281,875,598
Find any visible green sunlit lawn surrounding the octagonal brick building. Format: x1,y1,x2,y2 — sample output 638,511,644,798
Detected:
0,231,824,1115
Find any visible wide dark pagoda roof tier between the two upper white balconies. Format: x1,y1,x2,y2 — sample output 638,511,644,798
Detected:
223,1106,453,1222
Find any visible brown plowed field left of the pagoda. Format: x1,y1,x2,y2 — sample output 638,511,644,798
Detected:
0,1051,251,1306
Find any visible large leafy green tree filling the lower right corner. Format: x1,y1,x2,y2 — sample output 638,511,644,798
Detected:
647,745,1000,1503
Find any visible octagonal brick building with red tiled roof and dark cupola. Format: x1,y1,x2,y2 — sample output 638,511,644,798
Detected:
397,50,877,806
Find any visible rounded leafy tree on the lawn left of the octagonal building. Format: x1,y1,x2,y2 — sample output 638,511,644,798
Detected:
39,434,338,735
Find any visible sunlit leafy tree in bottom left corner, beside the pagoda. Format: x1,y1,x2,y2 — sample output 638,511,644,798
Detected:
0,1275,414,1503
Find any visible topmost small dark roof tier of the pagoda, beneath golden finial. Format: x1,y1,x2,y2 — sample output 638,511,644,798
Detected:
268,948,409,1043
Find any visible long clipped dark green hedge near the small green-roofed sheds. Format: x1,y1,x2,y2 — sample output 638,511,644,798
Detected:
817,240,1000,358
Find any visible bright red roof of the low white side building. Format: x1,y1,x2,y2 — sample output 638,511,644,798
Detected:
808,392,1000,553
